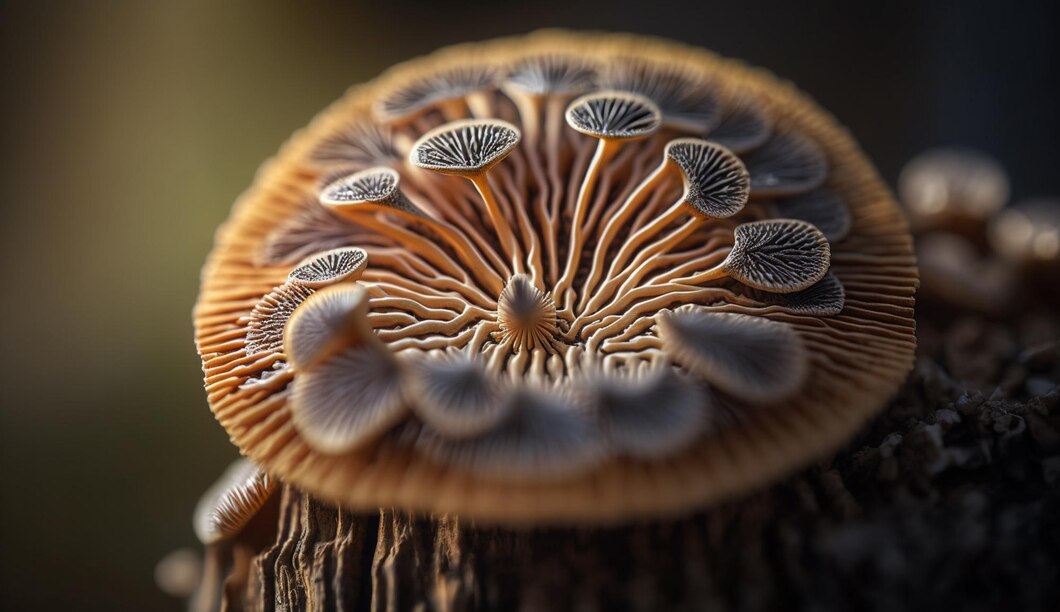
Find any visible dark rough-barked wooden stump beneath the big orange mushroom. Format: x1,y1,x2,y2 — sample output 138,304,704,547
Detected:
200,314,1060,611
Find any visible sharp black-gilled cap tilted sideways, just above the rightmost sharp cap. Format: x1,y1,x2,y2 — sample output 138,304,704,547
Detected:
666,138,750,218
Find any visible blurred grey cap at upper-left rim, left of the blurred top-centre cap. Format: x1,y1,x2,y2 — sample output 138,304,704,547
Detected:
372,62,498,123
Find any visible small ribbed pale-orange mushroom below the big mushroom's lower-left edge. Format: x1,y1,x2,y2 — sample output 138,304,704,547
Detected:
194,458,276,545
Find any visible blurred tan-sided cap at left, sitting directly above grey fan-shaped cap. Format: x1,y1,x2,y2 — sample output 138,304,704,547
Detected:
283,284,374,368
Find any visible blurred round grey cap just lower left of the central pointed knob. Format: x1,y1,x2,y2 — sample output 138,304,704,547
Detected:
405,351,511,438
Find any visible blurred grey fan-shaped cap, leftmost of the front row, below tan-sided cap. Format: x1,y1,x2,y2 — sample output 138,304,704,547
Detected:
289,346,406,454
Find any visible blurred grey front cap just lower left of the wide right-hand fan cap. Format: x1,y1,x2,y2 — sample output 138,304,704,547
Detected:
576,365,711,459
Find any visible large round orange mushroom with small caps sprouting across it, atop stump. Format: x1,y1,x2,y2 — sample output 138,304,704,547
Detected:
195,32,917,522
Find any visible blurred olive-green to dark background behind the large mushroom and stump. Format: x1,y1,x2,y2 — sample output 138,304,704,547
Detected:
0,0,1060,610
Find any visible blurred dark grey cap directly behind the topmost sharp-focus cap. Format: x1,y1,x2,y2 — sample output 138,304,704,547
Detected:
601,56,720,134
